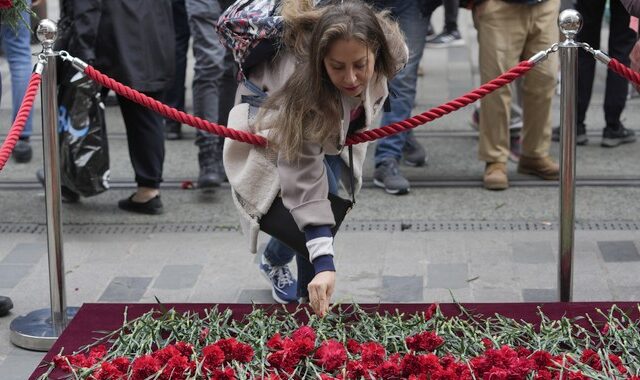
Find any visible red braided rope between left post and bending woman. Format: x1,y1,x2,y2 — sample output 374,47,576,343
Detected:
84,66,267,146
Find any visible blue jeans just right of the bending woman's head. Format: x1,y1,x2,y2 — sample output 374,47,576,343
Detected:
374,0,429,165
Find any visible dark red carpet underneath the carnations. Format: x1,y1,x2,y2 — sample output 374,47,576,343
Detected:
29,302,640,380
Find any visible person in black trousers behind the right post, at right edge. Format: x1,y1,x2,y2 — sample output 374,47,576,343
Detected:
576,0,636,147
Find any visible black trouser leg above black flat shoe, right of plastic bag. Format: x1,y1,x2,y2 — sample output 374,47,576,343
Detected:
118,91,164,189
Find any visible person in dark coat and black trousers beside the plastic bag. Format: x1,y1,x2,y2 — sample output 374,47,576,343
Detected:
60,0,175,214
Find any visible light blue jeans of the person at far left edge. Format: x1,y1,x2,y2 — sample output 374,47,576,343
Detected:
0,0,33,139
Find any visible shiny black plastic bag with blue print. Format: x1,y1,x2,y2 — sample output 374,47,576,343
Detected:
58,73,109,197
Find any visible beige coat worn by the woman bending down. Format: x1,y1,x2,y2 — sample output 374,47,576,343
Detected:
223,48,406,253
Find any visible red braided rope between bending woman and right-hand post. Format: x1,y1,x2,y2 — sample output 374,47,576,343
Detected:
346,61,535,145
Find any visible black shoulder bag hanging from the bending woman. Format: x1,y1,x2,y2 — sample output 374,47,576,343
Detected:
260,146,356,257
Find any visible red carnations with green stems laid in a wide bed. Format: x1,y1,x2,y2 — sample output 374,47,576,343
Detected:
41,305,640,380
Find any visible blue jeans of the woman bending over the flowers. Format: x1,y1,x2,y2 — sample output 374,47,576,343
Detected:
264,156,344,297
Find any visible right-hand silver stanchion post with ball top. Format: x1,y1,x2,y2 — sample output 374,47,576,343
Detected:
558,9,582,302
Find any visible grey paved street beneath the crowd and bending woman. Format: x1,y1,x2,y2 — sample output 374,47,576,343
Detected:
0,1,640,380
